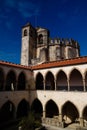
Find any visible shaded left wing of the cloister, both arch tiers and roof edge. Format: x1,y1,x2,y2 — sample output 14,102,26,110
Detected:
0,62,32,125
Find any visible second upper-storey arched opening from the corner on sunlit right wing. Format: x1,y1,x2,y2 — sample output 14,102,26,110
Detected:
45,72,55,90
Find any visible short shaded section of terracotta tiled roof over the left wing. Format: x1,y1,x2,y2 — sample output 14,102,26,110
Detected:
0,61,31,70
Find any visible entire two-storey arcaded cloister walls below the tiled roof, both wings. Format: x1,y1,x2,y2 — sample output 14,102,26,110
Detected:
0,61,87,126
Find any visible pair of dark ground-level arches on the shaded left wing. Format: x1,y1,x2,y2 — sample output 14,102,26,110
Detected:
0,99,30,122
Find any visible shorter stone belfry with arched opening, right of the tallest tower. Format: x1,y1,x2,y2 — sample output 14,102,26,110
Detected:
37,27,49,62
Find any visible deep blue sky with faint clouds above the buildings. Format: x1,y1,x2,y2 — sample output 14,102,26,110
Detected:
0,0,87,64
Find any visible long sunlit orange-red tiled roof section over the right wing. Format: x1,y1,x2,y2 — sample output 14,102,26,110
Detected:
32,56,87,70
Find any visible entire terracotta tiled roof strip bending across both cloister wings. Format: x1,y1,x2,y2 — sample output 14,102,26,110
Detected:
0,56,87,70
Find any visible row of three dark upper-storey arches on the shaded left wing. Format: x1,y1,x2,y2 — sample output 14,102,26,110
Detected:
0,68,26,91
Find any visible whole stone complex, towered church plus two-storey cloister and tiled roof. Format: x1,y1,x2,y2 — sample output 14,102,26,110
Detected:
0,24,87,128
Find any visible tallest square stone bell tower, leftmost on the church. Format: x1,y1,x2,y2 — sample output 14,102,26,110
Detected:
21,23,37,66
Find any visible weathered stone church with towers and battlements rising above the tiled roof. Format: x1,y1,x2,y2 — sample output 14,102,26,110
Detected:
21,24,80,65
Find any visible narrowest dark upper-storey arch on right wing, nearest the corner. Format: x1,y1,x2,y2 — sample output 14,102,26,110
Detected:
36,73,44,90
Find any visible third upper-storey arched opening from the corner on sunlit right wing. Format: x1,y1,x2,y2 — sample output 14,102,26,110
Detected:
56,71,68,90
